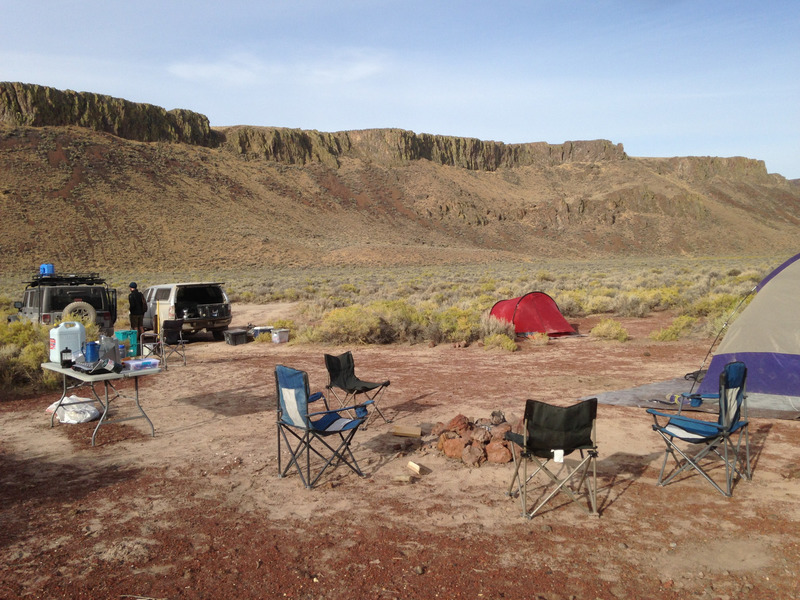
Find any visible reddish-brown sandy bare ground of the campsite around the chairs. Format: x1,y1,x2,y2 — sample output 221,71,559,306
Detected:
0,305,800,600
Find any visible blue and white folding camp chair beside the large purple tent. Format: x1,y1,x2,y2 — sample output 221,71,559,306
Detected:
647,361,752,496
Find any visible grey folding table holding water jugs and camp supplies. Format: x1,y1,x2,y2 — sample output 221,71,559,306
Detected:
42,362,161,446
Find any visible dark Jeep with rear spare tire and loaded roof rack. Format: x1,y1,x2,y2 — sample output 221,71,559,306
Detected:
9,273,117,336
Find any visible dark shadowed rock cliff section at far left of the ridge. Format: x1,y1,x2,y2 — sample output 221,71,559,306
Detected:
0,82,218,146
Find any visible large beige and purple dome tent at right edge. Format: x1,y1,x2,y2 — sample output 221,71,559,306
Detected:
697,254,800,411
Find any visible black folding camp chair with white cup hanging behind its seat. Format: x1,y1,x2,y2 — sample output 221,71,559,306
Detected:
505,398,599,519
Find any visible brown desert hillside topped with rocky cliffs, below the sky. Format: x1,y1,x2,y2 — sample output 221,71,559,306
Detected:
0,83,800,273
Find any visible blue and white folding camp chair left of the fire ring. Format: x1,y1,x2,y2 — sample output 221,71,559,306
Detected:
275,365,371,488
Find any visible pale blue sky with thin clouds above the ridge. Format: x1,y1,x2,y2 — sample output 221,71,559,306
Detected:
0,0,800,179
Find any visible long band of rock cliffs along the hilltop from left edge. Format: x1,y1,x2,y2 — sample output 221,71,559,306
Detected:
0,82,626,171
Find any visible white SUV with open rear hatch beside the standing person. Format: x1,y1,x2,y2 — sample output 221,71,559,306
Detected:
142,282,233,340
